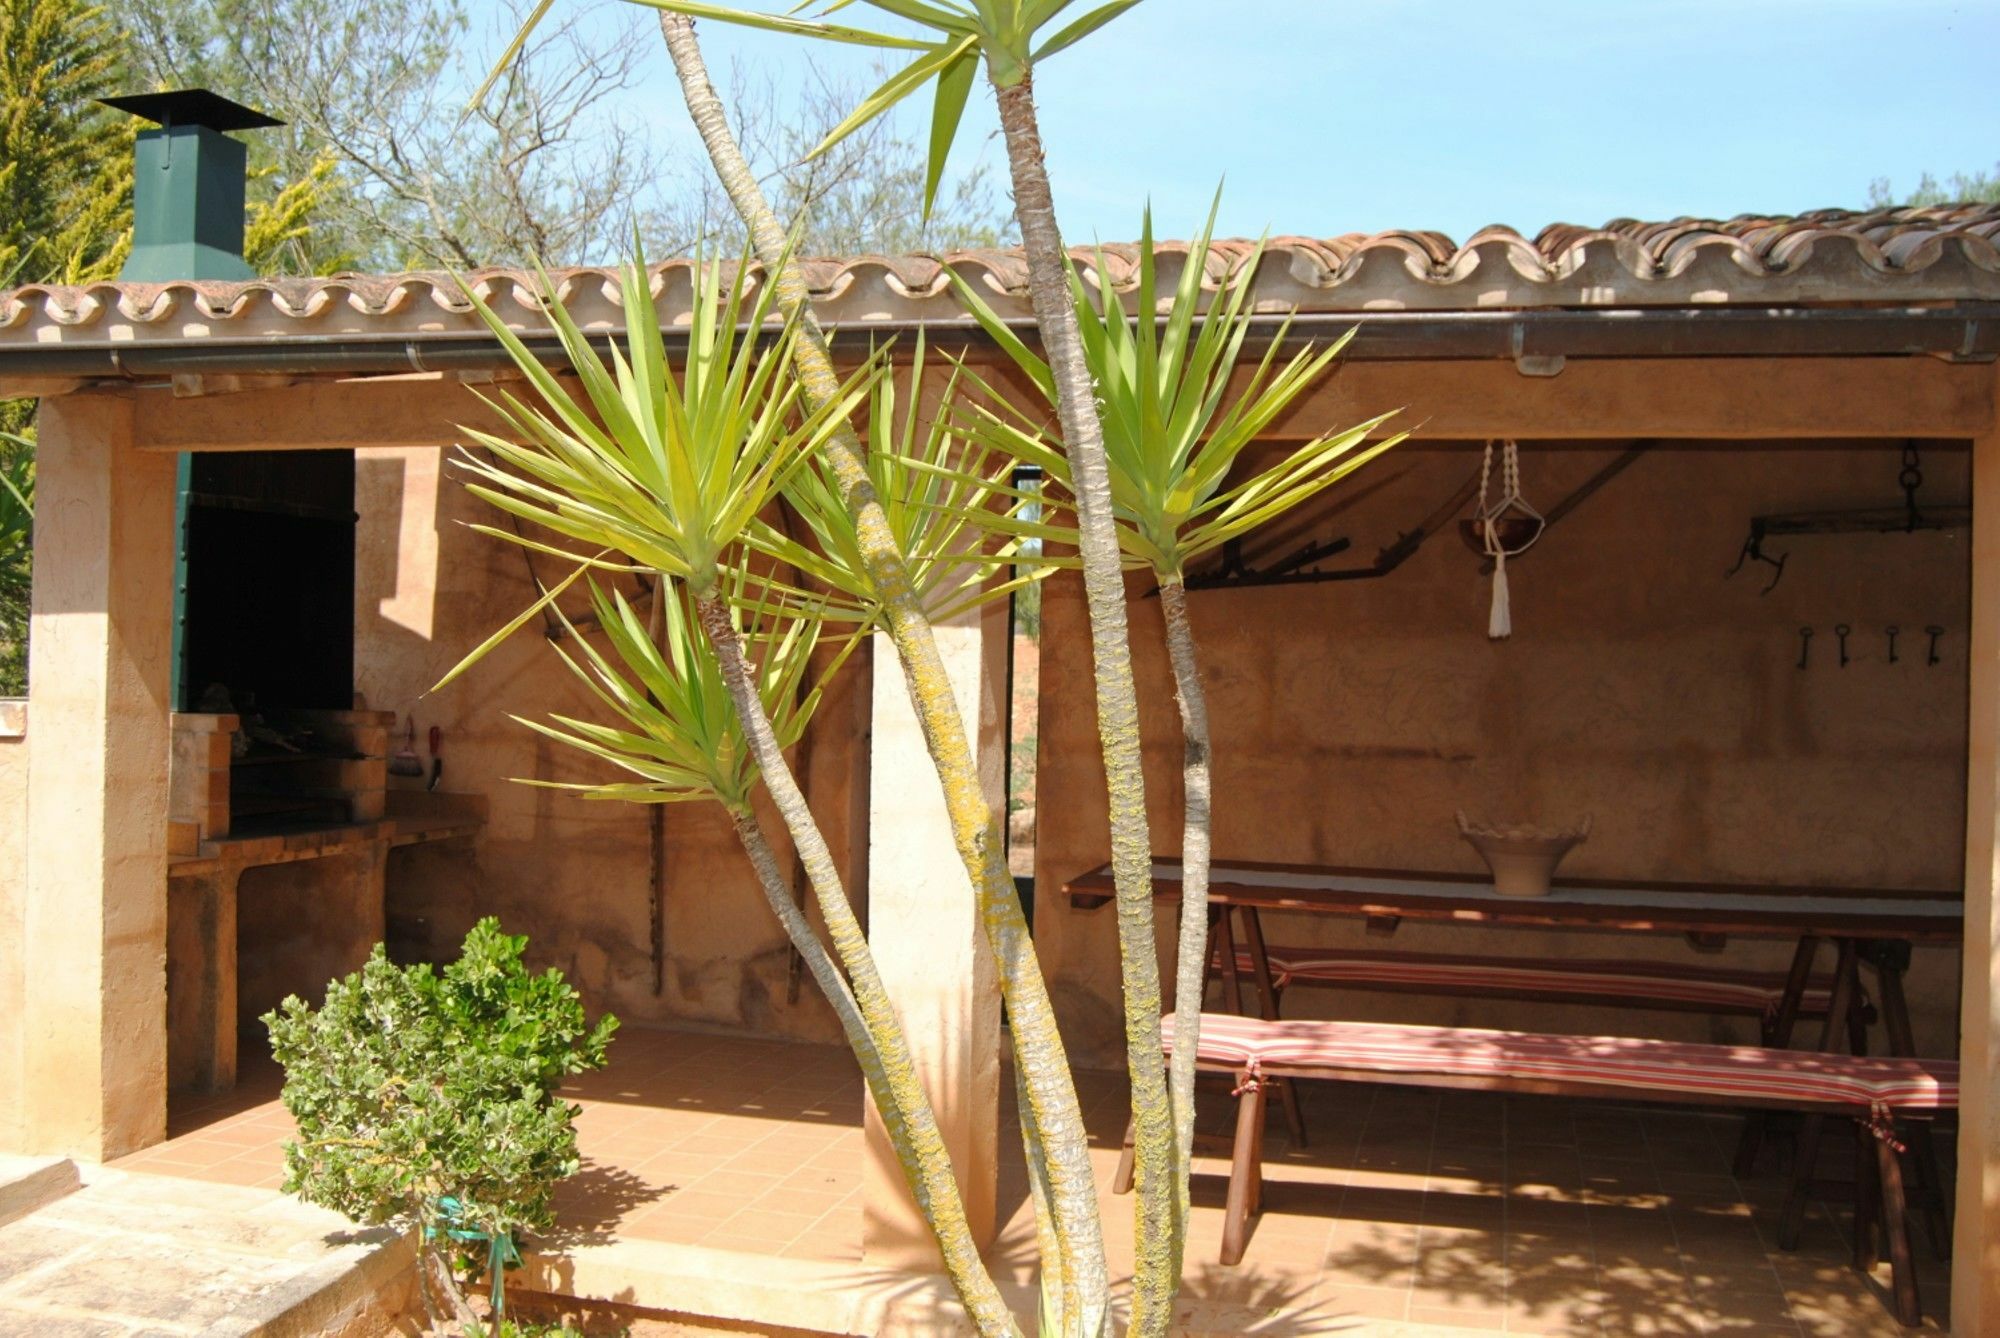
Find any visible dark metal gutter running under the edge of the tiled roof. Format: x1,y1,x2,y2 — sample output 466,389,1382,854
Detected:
0,302,2000,388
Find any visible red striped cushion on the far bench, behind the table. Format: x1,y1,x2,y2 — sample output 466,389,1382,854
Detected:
1236,948,1832,1016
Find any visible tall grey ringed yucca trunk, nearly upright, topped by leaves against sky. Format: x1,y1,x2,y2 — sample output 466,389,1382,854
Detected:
994,76,1186,1334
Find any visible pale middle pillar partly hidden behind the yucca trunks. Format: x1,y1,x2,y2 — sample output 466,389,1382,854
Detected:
862,602,1006,1272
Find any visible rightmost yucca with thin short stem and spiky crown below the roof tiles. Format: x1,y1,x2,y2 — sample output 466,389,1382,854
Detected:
952,208,1402,1190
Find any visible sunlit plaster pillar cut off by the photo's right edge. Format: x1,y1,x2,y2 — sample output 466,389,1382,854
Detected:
1952,384,2000,1334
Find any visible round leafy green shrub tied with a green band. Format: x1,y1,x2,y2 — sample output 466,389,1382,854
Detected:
264,918,618,1318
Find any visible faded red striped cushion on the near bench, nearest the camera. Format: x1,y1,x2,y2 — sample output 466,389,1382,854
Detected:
1162,1012,1958,1116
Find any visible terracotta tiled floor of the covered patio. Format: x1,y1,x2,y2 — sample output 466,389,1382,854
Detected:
122,1028,1948,1338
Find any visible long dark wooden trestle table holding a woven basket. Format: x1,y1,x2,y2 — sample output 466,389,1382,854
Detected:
1062,860,1964,1248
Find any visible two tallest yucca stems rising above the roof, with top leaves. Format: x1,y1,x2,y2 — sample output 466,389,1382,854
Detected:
488,0,1160,1336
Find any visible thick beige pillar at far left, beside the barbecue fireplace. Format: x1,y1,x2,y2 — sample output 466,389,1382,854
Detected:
22,394,174,1160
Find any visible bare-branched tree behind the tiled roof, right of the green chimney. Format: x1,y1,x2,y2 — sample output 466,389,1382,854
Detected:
128,0,1004,272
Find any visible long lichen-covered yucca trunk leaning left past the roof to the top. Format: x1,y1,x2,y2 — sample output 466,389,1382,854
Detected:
660,12,1110,1334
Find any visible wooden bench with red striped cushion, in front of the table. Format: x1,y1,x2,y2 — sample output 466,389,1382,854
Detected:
1112,1014,1958,1326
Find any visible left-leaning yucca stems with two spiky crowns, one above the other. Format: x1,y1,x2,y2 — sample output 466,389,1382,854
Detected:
440,248,1012,1332
